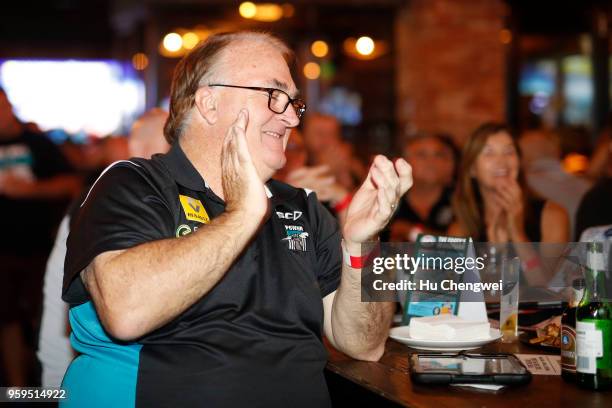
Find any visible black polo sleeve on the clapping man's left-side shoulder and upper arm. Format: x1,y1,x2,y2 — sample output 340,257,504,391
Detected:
62,161,174,304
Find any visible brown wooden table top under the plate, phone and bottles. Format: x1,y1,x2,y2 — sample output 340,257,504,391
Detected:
327,339,612,408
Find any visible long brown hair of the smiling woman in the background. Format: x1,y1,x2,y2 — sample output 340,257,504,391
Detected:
453,122,525,241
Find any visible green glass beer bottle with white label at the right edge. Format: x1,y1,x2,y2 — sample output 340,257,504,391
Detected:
576,242,612,390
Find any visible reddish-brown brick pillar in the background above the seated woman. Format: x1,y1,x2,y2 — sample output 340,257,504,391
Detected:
395,0,506,143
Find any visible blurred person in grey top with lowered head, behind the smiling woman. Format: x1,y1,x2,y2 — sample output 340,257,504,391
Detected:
519,130,592,237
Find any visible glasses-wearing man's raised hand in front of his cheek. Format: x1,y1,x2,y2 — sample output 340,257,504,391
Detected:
221,109,268,220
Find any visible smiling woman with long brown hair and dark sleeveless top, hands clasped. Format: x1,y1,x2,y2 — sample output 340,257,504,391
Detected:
449,123,570,285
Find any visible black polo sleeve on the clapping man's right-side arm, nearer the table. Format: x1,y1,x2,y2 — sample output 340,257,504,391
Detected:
308,192,342,297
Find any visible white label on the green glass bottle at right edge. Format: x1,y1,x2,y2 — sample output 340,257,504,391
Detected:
576,319,612,374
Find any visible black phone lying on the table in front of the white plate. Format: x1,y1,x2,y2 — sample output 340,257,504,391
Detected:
410,352,531,385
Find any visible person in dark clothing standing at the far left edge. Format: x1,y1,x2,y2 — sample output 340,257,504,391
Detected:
0,88,81,386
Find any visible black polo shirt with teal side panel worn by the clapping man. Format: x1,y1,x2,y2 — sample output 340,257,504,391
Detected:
63,143,342,407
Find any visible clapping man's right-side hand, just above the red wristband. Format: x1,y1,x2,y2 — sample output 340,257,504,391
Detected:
343,155,412,245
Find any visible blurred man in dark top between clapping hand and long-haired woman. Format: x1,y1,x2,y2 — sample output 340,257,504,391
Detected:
388,134,459,242
